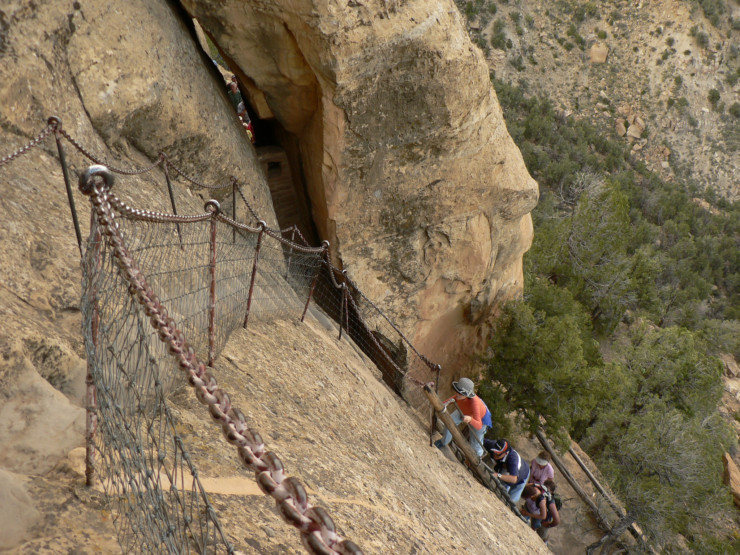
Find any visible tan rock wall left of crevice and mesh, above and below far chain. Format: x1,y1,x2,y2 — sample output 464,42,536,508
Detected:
0,0,275,553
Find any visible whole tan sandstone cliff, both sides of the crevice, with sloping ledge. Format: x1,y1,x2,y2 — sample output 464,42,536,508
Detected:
0,0,544,553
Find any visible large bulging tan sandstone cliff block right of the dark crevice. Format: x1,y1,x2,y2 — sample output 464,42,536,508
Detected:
183,0,538,378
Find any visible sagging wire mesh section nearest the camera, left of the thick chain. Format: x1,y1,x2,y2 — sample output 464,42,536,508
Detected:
82,218,233,553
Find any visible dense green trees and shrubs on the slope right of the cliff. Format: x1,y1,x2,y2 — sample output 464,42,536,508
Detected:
480,79,740,552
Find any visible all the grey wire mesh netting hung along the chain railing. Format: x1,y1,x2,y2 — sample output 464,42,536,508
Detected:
0,122,436,553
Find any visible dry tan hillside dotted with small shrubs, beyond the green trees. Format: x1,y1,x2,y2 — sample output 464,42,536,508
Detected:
466,0,740,200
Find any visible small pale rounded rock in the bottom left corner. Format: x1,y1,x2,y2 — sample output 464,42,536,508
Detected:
0,468,41,551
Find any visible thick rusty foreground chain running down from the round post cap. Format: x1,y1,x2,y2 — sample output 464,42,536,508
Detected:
80,166,362,555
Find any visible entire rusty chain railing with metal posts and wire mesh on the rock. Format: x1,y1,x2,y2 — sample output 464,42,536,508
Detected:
0,117,446,553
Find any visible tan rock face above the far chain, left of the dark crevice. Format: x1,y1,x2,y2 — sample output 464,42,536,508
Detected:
0,0,275,225
